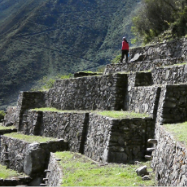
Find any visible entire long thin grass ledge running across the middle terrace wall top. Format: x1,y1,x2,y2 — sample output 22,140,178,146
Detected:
32,108,149,119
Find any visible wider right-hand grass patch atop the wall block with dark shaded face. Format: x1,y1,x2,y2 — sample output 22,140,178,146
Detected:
94,111,149,119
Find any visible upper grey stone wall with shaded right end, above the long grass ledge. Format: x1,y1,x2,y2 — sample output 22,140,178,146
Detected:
48,74,127,110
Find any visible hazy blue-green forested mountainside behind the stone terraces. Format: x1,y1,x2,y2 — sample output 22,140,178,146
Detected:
0,0,140,108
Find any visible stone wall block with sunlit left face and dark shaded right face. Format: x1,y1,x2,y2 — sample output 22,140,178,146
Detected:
84,114,154,163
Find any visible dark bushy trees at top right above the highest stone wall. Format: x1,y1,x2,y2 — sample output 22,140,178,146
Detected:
132,0,187,43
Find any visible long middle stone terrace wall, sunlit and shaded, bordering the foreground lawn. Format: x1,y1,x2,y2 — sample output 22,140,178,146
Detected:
20,111,154,163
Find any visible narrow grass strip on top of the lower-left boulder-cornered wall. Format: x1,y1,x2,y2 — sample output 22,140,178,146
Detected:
4,133,57,143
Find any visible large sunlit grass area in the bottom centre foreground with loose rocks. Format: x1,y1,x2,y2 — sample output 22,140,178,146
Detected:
55,152,154,186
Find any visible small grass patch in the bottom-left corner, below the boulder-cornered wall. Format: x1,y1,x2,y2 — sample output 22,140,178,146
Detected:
0,165,24,179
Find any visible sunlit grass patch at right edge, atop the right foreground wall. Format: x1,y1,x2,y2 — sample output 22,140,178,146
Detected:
164,122,187,145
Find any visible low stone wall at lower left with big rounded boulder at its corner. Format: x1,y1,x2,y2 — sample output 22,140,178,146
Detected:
0,135,67,176
